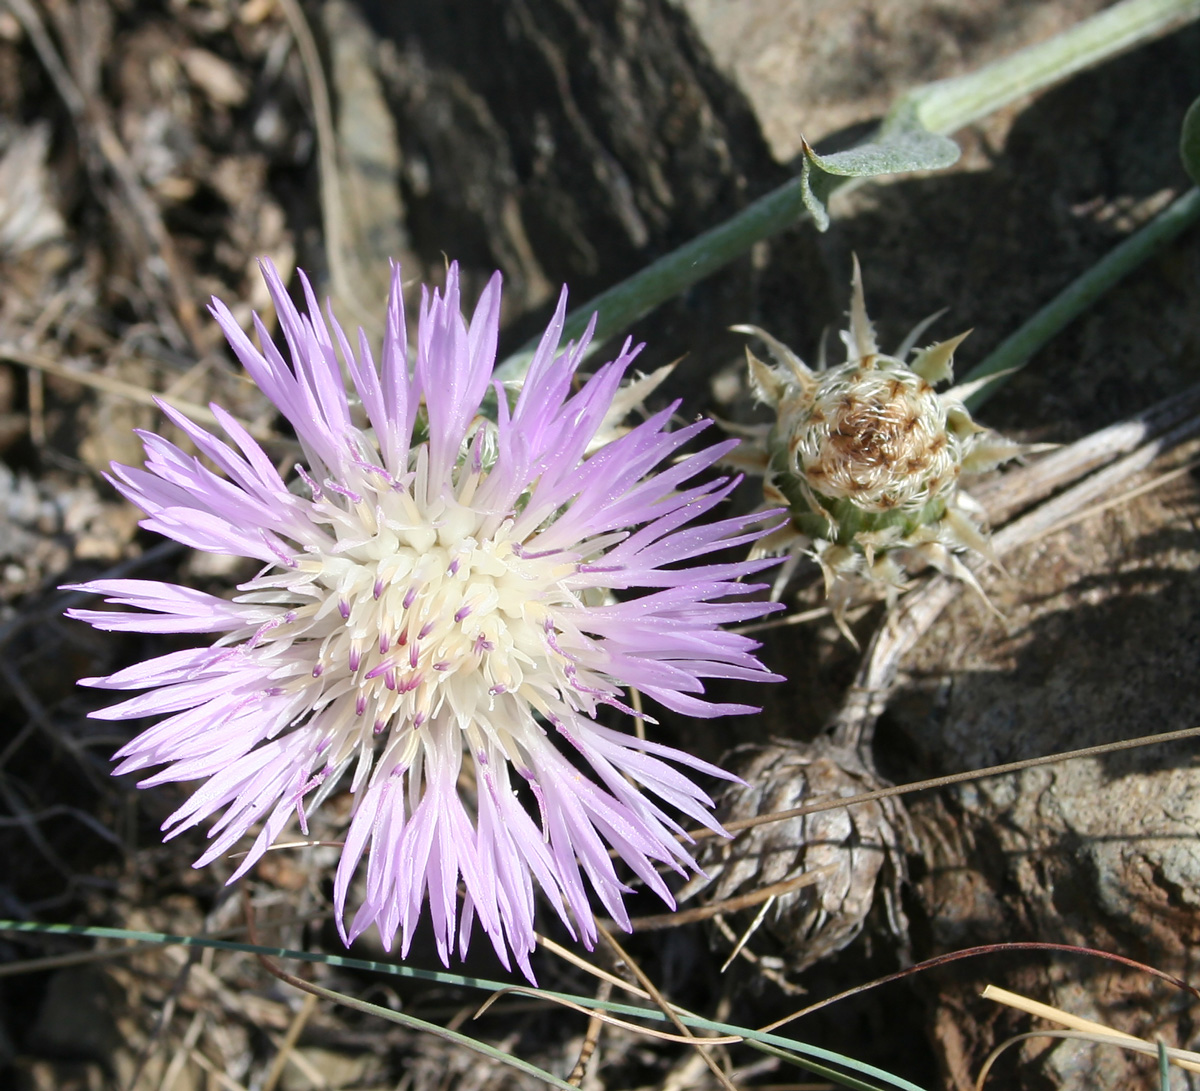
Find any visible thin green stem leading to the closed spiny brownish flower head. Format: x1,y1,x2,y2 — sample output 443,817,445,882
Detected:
962,188,1200,409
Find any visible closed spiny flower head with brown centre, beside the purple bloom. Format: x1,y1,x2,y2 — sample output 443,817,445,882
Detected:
727,259,1039,640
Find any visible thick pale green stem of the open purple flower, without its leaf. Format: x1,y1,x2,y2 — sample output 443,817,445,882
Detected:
496,0,1200,382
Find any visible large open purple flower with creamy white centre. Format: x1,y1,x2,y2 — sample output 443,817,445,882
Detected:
71,264,778,976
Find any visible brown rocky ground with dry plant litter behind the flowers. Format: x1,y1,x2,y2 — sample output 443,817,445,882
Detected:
0,0,1200,1091
